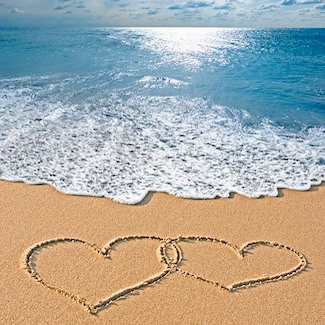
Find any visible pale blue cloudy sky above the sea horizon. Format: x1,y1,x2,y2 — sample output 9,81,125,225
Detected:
0,0,325,27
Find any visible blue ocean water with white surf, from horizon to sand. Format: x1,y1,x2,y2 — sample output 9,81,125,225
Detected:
0,28,325,204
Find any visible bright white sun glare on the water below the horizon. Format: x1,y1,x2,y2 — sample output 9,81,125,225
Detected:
112,28,247,69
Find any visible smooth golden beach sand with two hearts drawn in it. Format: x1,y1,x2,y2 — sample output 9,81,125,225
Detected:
0,178,325,325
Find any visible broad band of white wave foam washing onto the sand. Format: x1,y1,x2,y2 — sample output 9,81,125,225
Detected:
0,80,325,204
